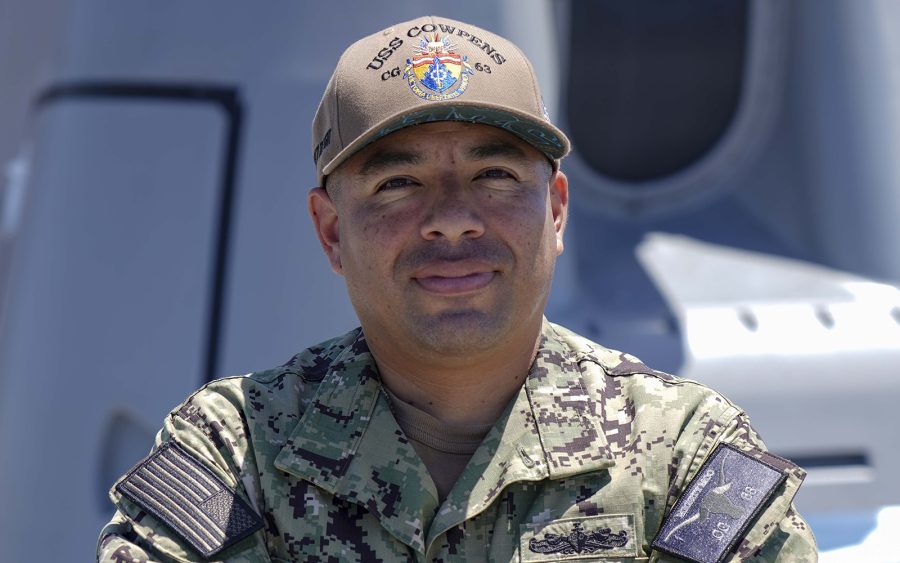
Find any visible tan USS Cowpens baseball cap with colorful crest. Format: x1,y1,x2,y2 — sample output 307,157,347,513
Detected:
312,16,570,186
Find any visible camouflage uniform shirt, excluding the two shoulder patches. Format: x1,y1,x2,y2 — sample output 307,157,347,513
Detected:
98,321,816,563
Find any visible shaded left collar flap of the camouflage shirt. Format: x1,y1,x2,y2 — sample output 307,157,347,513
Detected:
275,329,438,551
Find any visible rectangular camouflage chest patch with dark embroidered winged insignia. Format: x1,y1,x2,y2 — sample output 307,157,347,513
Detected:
519,514,637,562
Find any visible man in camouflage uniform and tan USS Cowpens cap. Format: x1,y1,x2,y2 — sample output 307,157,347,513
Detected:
98,17,816,562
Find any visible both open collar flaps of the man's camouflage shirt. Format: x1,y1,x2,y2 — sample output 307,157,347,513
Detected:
275,319,613,552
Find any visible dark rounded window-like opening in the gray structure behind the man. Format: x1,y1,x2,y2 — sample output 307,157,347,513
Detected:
566,0,749,182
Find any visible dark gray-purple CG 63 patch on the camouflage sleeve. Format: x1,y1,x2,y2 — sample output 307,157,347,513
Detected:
652,444,787,563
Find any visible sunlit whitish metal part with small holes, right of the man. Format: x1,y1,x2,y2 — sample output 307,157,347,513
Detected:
639,234,900,511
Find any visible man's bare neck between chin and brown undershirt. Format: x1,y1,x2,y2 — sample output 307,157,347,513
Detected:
372,328,540,424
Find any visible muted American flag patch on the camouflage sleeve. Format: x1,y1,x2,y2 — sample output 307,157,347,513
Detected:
116,442,262,557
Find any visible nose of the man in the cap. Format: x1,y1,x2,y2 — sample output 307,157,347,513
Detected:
422,181,484,242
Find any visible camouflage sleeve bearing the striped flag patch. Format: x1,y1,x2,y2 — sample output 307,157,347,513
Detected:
97,388,270,563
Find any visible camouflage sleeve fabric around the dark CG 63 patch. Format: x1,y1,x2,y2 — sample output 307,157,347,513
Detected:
651,404,818,563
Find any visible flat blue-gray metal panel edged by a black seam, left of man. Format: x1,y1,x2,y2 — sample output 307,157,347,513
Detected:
0,102,229,561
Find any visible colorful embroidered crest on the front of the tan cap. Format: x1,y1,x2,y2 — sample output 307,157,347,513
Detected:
403,33,475,101
